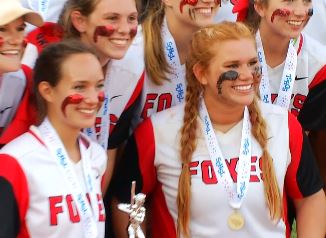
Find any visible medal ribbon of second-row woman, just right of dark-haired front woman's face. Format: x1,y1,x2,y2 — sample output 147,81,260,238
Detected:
83,80,110,151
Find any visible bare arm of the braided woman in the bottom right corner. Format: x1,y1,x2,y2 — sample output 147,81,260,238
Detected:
294,190,326,238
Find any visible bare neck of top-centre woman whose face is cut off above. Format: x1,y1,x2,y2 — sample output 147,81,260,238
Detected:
165,9,198,64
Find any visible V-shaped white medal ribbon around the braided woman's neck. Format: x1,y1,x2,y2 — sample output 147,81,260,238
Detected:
199,99,251,209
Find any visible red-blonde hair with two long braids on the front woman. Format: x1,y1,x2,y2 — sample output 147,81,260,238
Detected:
177,22,282,237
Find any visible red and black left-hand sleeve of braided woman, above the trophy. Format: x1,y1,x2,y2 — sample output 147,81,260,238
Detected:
112,120,157,203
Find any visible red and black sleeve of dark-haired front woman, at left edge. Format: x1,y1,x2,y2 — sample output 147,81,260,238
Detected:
0,154,29,238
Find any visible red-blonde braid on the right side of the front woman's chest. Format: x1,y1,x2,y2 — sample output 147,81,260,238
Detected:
249,96,282,221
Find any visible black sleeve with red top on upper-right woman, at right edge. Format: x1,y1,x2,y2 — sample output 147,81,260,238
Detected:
298,65,326,130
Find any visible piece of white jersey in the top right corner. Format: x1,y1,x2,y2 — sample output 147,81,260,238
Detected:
303,0,326,45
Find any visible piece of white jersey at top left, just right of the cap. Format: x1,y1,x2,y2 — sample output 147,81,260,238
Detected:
20,0,67,32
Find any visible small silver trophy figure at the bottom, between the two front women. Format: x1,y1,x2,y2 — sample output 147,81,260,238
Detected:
118,181,146,238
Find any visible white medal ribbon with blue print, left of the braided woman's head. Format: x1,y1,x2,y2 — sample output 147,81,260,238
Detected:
161,18,185,103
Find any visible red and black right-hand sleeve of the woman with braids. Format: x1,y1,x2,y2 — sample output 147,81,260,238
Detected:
285,113,323,199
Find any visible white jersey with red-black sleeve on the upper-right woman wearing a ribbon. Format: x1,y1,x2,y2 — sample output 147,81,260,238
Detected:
267,34,326,130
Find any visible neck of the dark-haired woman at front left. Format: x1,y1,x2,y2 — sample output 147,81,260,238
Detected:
48,114,80,162
